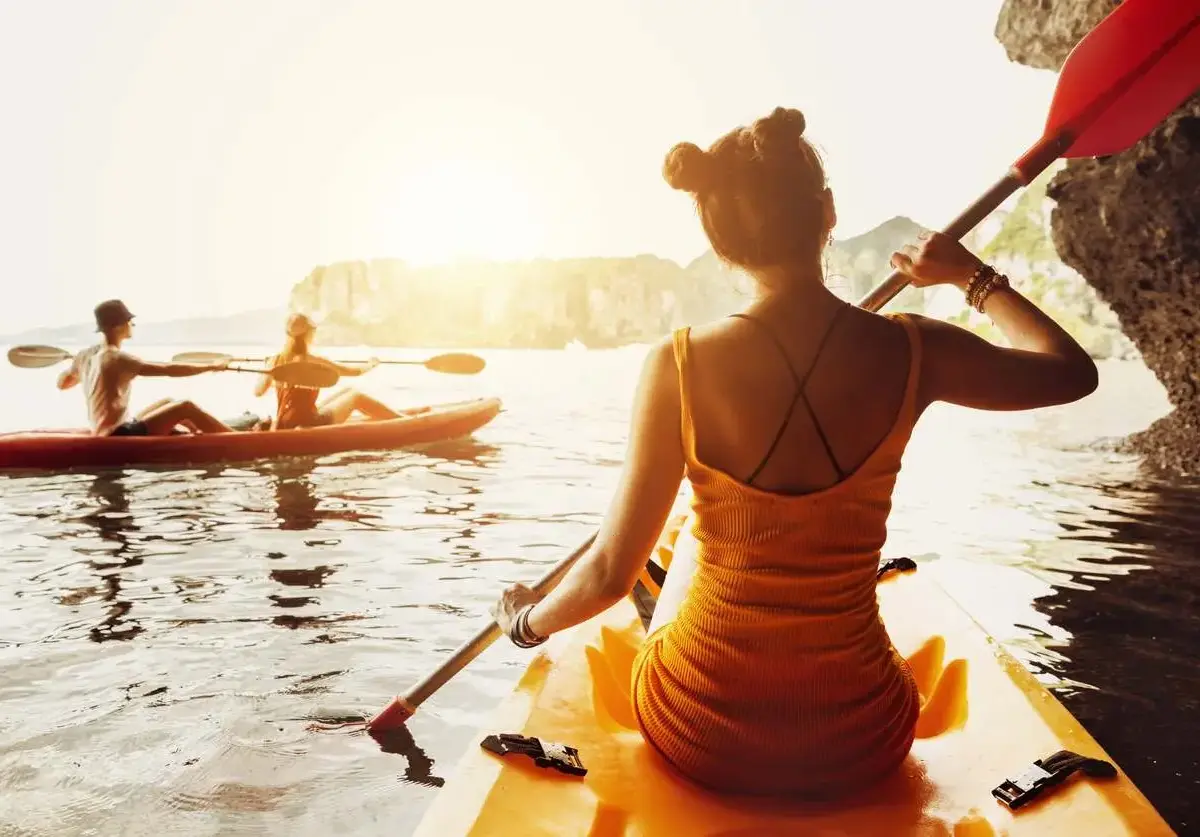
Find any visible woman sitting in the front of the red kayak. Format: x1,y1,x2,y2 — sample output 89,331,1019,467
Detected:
254,314,400,430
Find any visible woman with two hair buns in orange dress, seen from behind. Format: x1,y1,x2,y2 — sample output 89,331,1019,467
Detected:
494,108,1097,797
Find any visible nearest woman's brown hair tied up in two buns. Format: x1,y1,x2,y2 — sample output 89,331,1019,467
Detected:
662,108,826,269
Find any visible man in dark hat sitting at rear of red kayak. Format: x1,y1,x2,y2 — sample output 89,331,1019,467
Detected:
59,300,230,436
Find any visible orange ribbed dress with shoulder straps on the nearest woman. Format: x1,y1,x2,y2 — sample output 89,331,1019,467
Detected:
632,315,920,797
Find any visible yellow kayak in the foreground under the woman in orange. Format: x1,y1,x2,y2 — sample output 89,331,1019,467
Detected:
416,519,1174,837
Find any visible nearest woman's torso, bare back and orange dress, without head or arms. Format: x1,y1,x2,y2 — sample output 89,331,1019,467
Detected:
635,311,920,795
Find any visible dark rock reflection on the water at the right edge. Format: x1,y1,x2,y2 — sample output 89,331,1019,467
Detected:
1040,480,1200,833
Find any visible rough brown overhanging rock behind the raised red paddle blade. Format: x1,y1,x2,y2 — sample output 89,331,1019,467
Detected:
996,0,1200,472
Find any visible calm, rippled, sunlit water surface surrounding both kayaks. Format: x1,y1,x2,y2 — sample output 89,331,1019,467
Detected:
0,348,1200,837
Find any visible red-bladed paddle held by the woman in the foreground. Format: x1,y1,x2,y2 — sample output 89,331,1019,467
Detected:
367,0,1200,731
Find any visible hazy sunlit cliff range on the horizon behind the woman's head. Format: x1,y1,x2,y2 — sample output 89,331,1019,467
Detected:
283,218,923,348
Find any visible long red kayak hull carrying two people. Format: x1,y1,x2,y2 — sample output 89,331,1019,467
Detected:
0,398,500,470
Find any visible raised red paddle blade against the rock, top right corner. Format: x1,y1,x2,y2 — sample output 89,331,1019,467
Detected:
1044,0,1200,157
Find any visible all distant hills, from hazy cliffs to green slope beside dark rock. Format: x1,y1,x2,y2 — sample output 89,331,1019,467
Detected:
290,206,1135,357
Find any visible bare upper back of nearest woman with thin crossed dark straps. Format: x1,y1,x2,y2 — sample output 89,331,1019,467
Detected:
689,305,911,494
